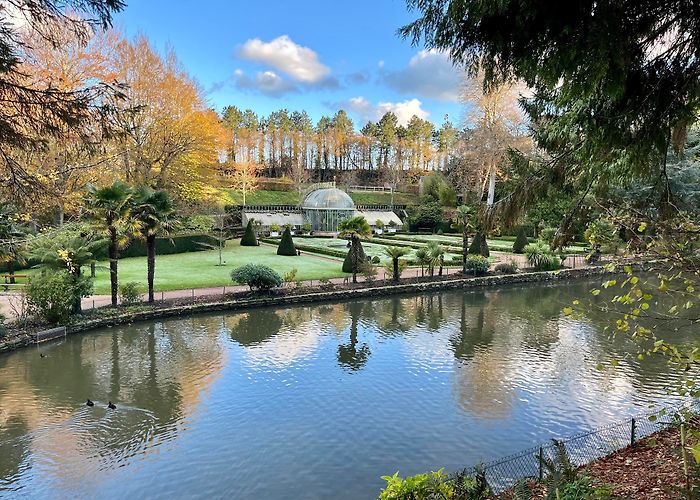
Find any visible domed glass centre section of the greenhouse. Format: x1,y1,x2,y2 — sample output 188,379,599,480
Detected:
301,188,355,232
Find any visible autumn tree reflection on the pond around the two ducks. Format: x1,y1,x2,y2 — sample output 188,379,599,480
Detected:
0,318,222,487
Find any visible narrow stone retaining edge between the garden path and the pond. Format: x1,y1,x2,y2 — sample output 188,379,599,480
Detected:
0,263,644,353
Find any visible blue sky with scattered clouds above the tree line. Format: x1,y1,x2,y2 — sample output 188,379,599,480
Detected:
115,0,462,128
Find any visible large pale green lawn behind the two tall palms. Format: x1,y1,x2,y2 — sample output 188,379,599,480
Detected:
25,240,345,295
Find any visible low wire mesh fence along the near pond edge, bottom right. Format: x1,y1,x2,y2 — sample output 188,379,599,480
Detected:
474,404,699,493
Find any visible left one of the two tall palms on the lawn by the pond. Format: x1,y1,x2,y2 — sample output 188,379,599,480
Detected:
85,181,132,307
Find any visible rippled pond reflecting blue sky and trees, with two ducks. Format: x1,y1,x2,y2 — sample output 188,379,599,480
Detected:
0,283,690,499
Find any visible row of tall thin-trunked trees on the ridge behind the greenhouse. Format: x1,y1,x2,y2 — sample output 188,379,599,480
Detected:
222,106,459,183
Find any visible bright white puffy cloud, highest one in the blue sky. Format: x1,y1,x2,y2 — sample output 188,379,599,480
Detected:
238,35,331,83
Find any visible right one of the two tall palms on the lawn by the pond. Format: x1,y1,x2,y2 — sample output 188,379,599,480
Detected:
131,186,175,302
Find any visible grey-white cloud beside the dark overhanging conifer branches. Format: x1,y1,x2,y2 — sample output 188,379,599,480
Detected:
384,49,463,102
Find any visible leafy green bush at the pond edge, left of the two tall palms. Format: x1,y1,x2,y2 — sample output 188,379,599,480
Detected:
26,270,92,324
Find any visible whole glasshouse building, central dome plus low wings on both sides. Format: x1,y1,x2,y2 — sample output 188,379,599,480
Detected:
242,187,403,233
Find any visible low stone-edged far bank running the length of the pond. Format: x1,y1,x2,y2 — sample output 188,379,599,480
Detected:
0,263,642,353
